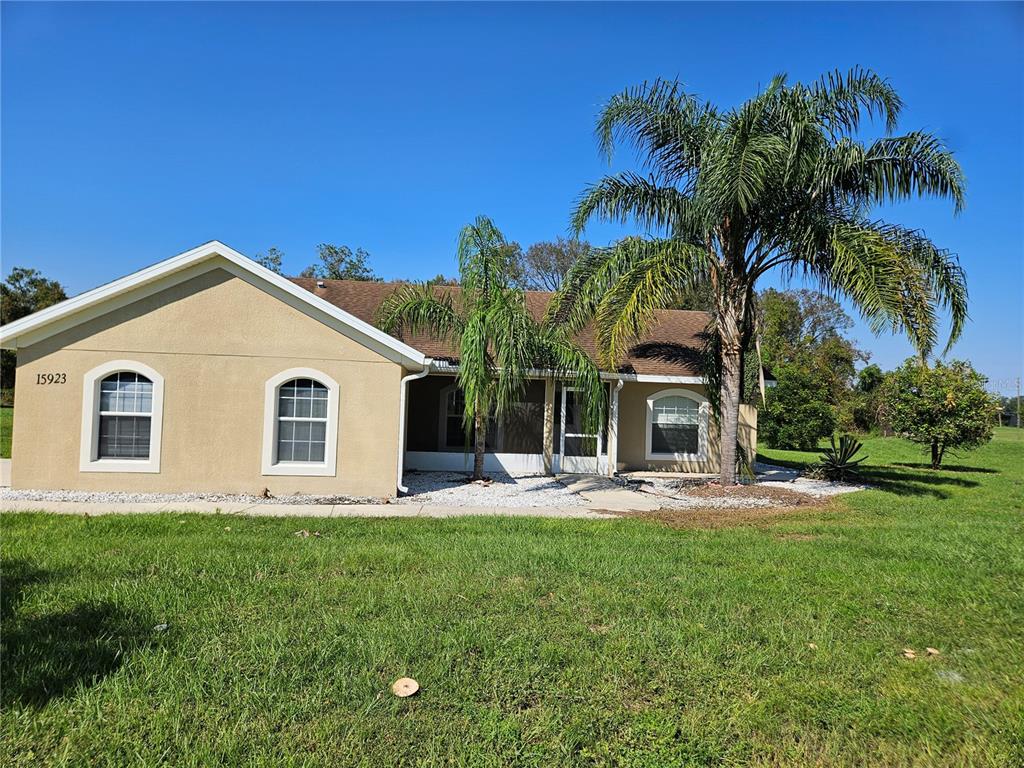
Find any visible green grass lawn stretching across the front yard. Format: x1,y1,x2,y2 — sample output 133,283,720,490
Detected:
0,429,1024,766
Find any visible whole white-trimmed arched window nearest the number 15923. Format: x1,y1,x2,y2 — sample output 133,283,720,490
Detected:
79,360,164,472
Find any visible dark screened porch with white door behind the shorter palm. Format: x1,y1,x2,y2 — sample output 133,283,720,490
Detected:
404,375,607,473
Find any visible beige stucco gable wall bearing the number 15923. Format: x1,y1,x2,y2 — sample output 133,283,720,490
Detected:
12,269,403,497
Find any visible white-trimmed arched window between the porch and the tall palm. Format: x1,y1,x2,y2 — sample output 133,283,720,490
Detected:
647,389,709,460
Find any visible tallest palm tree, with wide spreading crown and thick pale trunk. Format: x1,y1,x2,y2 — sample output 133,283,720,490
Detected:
551,70,967,484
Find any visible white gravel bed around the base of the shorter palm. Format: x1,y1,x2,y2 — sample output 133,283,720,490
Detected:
397,471,587,508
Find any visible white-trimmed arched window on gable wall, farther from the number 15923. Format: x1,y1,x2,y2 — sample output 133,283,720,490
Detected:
263,369,338,476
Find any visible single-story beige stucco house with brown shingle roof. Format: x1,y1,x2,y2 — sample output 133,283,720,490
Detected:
0,242,757,497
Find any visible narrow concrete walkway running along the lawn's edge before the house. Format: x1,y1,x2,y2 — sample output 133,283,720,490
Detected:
0,499,616,520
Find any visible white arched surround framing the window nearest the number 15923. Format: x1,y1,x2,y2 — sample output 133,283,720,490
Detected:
78,360,164,474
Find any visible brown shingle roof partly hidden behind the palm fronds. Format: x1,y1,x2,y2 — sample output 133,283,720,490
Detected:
290,278,708,376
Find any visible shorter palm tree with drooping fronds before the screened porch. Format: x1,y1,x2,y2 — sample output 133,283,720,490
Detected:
377,216,605,480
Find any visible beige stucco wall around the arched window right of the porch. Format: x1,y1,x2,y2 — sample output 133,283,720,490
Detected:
616,382,758,474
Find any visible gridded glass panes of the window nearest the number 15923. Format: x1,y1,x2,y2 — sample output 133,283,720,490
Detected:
96,371,153,459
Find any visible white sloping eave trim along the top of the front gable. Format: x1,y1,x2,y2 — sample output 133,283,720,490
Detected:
0,240,427,368
